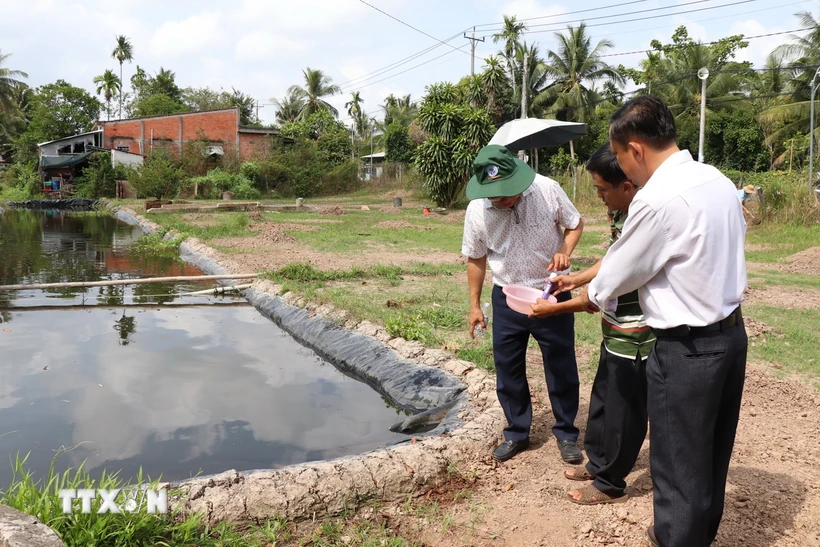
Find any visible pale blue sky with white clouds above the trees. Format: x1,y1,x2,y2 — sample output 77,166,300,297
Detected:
0,0,820,124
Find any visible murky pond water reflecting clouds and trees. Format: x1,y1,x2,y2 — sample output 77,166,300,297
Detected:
0,210,404,489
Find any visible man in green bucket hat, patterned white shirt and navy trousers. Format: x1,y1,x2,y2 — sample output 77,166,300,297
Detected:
461,145,583,464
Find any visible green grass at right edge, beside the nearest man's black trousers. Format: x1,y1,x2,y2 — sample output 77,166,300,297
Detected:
743,306,820,376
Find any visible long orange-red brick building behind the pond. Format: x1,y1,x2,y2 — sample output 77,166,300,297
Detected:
94,107,279,161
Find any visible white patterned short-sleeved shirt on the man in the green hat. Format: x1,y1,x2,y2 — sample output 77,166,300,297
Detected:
461,175,581,289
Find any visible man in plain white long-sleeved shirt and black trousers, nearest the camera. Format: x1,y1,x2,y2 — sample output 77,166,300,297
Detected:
582,97,748,547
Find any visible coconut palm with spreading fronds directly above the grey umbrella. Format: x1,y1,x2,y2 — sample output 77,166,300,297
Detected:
533,23,624,121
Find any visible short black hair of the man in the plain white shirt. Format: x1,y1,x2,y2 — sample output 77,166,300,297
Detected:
609,95,677,150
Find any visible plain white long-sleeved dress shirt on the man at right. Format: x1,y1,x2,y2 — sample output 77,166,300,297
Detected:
589,150,746,329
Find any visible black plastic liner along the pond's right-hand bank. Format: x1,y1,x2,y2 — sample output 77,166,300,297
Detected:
114,210,468,448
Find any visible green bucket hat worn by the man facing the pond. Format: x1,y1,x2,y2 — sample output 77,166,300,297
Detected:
467,144,535,200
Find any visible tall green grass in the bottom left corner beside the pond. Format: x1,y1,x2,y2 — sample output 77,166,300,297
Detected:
0,448,290,547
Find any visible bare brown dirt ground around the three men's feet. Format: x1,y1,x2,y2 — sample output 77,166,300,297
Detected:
382,354,820,547
